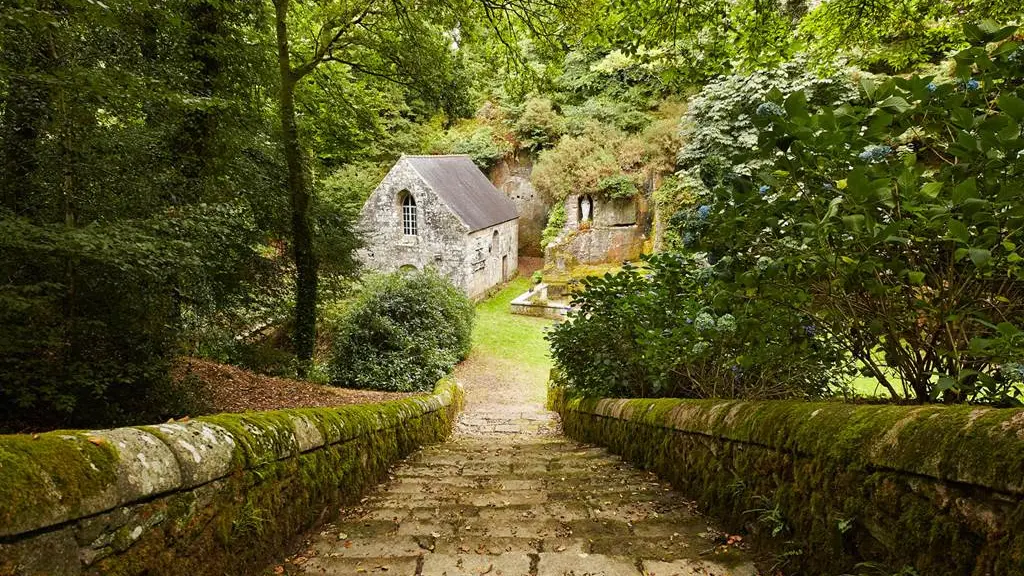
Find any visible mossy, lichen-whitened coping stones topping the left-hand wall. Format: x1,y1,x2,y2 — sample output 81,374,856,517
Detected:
0,378,461,538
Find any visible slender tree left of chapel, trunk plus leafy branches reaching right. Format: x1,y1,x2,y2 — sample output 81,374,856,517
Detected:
273,0,552,373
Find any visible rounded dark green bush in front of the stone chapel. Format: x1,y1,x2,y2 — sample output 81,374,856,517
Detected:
331,271,474,392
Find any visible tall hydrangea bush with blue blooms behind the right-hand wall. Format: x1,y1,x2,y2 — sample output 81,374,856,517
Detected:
689,24,1024,403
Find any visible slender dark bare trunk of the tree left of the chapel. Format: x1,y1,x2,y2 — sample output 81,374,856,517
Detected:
273,0,317,376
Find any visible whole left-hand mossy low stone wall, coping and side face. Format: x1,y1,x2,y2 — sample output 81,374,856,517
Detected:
0,379,462,576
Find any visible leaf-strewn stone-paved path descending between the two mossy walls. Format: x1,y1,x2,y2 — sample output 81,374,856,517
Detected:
272,276,755,576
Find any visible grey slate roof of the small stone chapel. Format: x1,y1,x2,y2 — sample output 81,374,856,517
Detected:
402,156,519,232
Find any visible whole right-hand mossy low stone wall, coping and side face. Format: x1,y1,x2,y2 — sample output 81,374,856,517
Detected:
549,381,1024,576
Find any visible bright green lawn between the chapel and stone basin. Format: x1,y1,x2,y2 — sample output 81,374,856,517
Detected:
473,277,552,382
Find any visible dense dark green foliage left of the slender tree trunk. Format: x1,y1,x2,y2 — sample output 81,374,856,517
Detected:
0,1,280,427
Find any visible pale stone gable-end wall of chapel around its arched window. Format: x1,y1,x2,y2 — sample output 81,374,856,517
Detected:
356,161,469,290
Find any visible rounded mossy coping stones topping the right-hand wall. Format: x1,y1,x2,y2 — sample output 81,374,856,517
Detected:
552,388,1024,496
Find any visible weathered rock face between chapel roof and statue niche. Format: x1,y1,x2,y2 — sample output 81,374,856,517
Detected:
488,151,551,256
